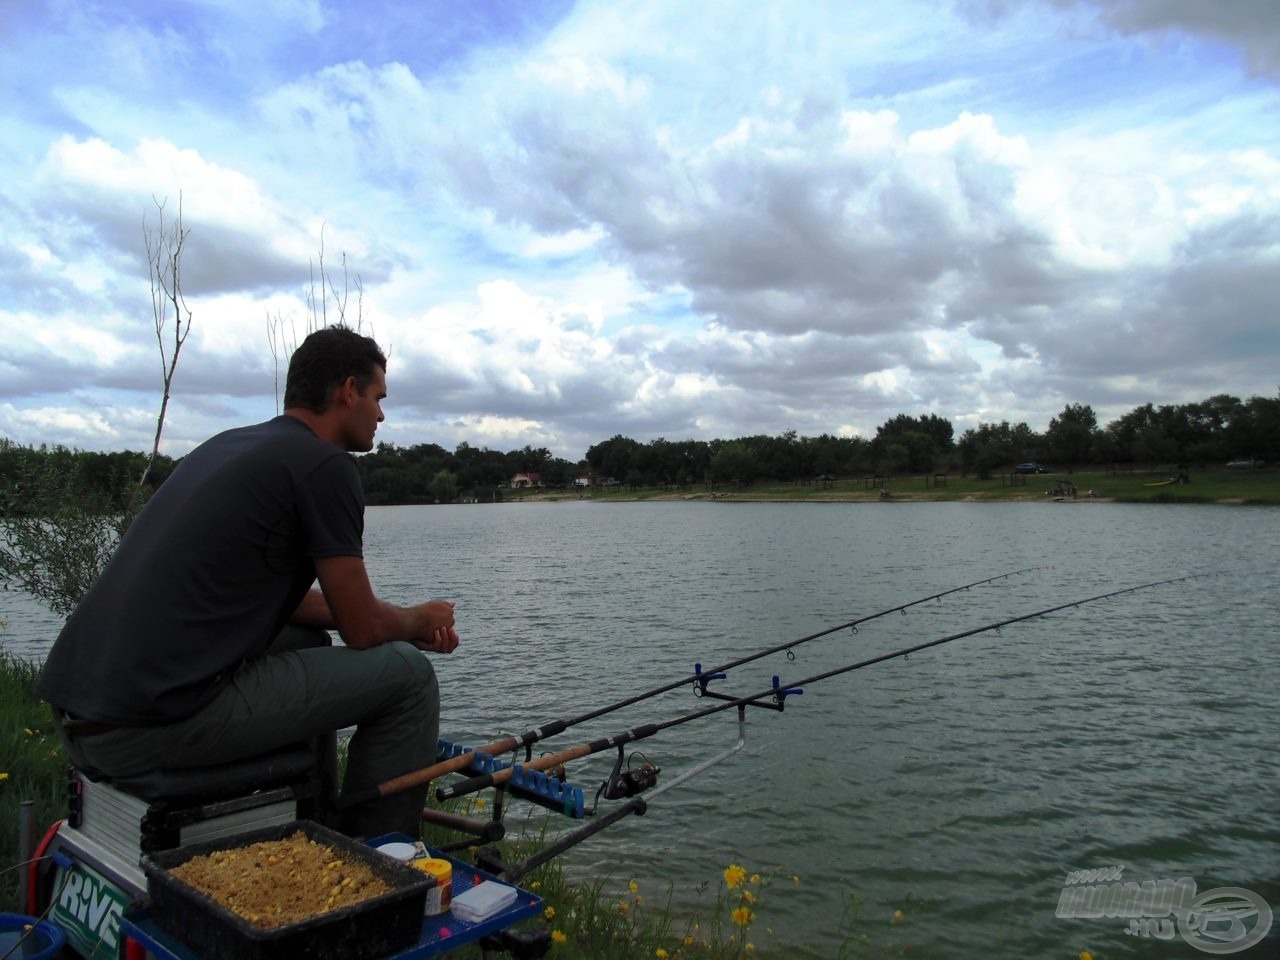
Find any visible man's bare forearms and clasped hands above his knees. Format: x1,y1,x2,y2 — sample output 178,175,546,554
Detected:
308,557,458,653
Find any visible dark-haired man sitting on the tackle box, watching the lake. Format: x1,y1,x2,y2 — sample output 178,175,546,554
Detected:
37,326,458,837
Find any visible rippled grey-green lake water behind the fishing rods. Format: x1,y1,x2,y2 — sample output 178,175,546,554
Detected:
0,500,1280,957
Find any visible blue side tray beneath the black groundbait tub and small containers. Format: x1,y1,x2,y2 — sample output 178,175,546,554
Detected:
120,836,543,960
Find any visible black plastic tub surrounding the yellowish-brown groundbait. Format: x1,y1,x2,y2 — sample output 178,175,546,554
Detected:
142,820,435,960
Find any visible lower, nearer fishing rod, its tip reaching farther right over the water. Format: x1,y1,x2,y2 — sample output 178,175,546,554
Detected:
435,573,1204,800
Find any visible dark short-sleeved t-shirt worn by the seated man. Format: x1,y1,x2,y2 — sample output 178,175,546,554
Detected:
37,416,364,726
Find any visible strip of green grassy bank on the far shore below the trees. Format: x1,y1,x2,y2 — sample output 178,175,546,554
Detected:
520,465,1280,506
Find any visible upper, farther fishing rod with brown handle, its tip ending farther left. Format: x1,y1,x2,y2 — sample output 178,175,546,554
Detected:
350,566,1043,808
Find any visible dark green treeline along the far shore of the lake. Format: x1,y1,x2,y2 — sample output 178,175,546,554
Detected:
0,394,1280,512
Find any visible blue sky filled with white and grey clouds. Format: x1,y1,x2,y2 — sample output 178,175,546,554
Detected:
0,0,1280,461
